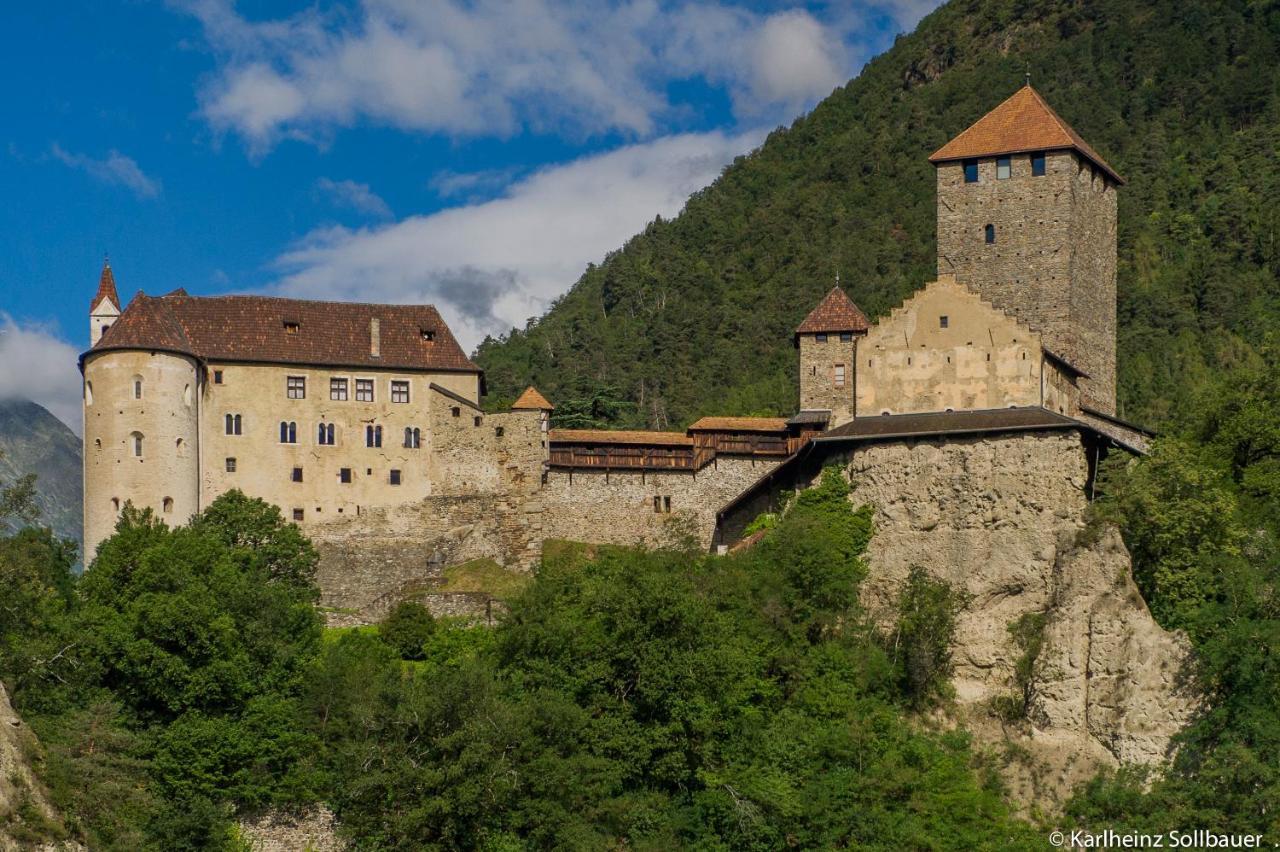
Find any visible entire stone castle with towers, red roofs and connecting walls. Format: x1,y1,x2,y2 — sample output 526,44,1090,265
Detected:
81,84,1146,583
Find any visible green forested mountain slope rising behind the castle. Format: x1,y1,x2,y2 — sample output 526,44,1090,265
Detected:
477,0,1280,427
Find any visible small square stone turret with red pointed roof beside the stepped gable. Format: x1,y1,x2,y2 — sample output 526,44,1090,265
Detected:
795,285,869,429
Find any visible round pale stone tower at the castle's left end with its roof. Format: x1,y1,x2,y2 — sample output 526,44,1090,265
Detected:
81,267,200,557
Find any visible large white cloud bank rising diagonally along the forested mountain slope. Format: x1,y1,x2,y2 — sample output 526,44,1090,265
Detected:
262,130,763,351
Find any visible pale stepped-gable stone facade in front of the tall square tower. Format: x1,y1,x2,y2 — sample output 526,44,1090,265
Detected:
858,275,1079,417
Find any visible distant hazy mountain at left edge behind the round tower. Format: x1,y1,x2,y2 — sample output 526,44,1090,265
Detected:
0,399,84,542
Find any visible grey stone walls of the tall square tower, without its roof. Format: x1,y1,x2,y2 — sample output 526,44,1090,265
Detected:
937,150,1116,413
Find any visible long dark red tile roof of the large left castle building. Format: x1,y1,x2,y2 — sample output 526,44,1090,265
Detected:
91,290,480,372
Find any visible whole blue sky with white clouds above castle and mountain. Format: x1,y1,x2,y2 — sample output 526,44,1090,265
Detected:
0,0,937,429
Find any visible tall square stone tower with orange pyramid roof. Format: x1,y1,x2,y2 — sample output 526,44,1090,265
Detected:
929,84,1124,414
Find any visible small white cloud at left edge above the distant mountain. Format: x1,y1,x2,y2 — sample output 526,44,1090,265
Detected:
0,313,82,435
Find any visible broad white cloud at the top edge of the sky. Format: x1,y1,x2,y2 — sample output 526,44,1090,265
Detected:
175,0,859,152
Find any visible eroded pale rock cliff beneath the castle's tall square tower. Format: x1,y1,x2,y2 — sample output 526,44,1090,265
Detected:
847,432,1197,785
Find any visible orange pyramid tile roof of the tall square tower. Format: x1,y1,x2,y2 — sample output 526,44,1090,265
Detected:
929,84,1124,183
